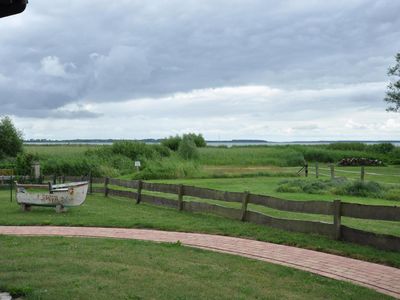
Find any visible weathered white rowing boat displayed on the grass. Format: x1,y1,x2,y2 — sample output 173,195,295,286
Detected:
16,181,89,212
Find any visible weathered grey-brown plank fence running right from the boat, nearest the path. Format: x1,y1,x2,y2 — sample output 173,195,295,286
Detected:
92,178,400,251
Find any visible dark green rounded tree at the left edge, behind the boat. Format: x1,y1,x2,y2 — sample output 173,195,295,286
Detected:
0,116,23,157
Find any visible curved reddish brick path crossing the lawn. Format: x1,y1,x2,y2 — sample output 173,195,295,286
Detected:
0,226,400,299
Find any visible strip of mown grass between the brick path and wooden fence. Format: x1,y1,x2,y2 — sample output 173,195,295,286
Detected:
0,191,400,267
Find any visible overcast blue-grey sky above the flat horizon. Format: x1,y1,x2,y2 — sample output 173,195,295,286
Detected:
0,0,400,141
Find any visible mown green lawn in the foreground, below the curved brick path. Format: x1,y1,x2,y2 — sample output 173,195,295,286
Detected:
0,236,390,300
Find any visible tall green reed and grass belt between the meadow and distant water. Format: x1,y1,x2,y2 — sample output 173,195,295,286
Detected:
16,141,400,179
